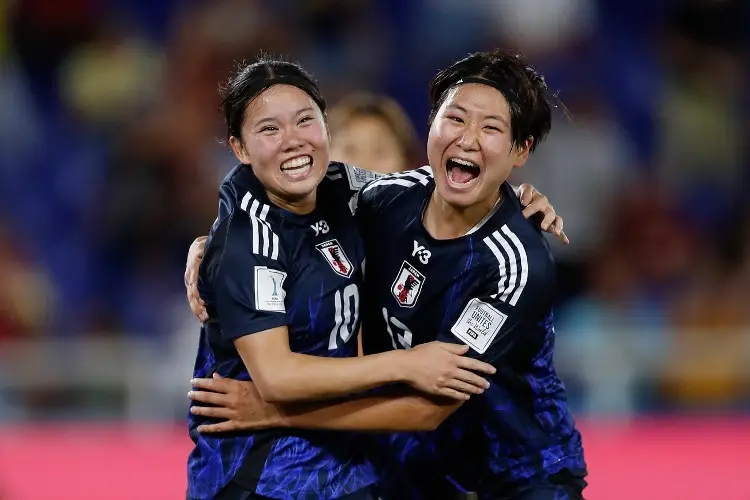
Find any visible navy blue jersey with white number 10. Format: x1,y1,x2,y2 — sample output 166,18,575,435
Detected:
188,163,375,499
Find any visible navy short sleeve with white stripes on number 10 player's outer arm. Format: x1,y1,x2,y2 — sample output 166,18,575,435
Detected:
205,211,289,340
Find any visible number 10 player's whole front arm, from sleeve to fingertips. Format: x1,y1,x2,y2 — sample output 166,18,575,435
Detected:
206,214,494,402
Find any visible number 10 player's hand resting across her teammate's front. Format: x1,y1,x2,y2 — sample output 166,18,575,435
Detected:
405,342,496,401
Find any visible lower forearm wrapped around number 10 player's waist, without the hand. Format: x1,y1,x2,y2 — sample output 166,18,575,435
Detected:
273,393,461,432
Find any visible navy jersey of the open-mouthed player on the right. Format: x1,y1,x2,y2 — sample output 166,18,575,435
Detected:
357,167,586,497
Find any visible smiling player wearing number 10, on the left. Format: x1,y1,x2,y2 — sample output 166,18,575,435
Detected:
188,60,512,500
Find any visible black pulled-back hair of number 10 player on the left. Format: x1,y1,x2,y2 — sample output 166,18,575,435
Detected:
219,56,326,140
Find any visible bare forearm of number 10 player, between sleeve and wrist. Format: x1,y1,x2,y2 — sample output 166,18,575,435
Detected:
251,351,406,402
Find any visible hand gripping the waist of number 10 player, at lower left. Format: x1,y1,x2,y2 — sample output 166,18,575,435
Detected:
188,373,280,433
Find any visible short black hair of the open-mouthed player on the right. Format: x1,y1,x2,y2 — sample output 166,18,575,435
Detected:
429,50,564,151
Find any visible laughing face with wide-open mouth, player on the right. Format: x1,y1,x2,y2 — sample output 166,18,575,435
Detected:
427,83,531,209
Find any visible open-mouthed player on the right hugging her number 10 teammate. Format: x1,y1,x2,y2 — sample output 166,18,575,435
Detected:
188,52,586,500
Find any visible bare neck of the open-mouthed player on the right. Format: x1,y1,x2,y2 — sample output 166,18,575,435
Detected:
423,190,501,240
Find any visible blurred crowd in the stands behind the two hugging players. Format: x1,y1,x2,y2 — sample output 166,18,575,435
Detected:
0,0,750,417
